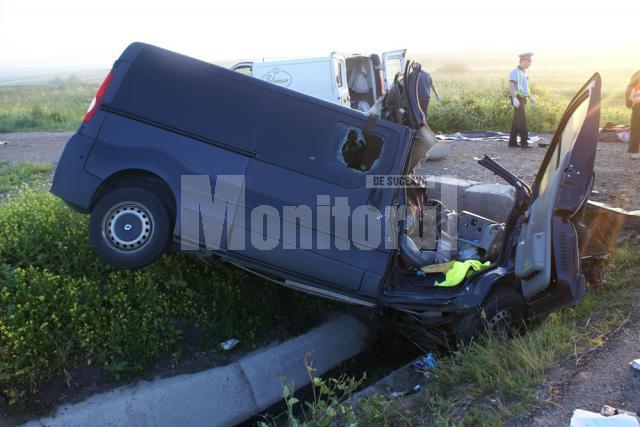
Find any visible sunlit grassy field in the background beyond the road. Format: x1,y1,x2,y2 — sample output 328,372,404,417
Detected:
0,66,633,133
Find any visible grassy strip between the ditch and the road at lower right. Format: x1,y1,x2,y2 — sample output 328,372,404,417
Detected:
276,246,640,426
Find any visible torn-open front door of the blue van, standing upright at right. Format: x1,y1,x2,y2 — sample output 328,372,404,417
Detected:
515,74,601,304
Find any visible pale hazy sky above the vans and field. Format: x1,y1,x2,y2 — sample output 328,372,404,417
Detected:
0,0,640,74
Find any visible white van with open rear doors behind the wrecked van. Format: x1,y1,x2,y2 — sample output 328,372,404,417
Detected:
231,49,406,111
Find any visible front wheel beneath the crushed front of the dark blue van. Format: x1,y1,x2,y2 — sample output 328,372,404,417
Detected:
455,285,527,344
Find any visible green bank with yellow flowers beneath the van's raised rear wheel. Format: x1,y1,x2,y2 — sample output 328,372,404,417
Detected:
0,188,327,408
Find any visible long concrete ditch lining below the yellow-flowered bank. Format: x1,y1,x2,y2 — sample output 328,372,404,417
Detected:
26,314,370,427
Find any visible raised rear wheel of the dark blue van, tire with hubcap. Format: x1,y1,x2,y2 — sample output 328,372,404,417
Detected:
89,187,171,268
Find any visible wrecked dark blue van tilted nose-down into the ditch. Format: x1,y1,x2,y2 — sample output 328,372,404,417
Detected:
51,43,601,340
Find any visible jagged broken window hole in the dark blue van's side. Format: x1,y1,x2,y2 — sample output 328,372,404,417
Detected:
338,126,383,172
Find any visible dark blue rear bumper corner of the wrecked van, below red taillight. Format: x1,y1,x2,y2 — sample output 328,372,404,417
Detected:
49,133,102,213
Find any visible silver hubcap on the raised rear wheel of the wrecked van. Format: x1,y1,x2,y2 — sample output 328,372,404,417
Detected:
102,202,153,252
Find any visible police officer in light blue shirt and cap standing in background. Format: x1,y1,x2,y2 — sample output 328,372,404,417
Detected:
509,52,536,148
